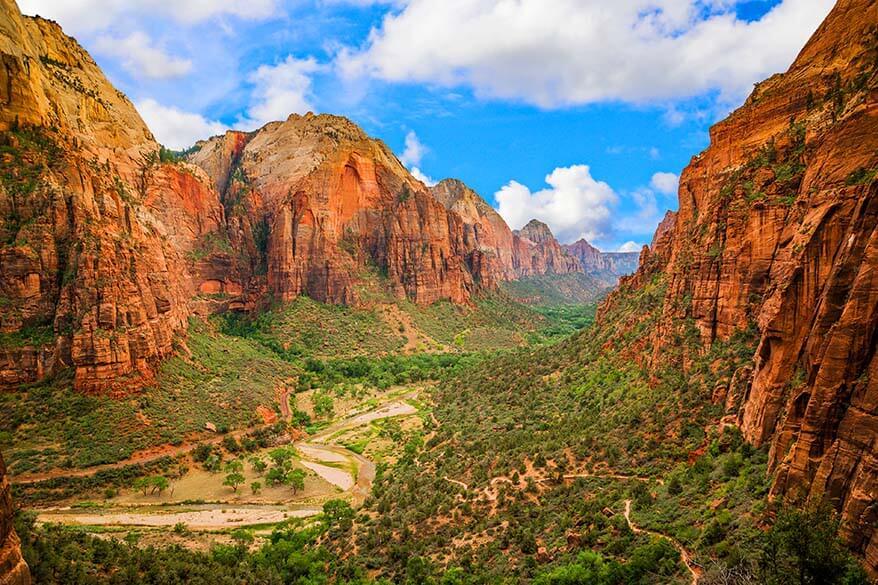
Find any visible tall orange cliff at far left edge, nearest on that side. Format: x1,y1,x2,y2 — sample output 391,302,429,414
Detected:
0,0,218,391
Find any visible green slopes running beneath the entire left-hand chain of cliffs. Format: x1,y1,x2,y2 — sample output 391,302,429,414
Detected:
0,288,579,474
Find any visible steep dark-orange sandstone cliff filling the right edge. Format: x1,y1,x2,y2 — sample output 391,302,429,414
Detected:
612,0,878,572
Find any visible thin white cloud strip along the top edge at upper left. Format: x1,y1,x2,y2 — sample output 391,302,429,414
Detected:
18,0,279,34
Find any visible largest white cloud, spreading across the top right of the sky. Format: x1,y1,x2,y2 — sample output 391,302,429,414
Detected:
338,0,834,107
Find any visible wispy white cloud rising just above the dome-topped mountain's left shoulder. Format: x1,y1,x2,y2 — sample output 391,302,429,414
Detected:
239,55,322,130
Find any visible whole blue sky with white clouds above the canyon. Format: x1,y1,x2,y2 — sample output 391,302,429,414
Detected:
20,0,833,250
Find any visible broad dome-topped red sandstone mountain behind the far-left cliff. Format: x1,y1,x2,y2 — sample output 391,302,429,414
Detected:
191,114,491,304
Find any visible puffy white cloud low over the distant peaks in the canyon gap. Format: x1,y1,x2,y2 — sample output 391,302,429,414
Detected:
494,165,618,242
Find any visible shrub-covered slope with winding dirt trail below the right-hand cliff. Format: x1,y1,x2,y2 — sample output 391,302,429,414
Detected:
324,278,872,583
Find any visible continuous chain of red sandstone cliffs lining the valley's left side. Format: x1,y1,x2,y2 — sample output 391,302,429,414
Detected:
0,0,604,392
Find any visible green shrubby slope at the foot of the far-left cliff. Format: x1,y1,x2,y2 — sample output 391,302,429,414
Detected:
0,320,299,473
